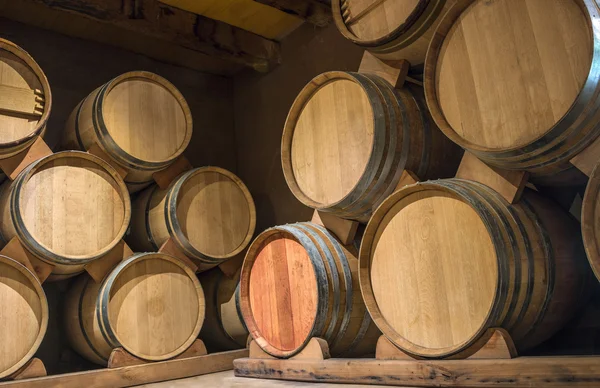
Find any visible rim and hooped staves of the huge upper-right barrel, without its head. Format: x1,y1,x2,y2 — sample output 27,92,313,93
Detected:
424,0,600,178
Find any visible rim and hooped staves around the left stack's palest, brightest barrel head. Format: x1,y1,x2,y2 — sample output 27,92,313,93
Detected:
0,151,131,280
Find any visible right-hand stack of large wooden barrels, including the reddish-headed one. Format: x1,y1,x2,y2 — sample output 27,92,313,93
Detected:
240,0,600,358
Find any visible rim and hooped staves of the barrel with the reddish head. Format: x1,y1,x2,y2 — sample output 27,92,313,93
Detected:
239,222,380,358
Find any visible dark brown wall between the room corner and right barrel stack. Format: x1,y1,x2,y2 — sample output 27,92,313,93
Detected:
234,24,363,232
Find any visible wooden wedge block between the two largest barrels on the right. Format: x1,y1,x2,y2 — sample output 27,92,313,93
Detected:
456,151,529,203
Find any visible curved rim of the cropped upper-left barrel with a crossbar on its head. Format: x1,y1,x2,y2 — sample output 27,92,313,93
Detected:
0,38,52,159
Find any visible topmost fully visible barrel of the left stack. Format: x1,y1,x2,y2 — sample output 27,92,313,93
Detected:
63,71,192,192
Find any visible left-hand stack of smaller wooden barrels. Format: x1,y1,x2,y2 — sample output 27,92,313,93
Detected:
0,39,256,379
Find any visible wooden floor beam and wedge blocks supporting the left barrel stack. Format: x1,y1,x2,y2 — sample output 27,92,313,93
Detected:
0,138,248,388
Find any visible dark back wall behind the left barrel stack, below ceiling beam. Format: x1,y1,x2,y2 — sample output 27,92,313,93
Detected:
0,18,236,172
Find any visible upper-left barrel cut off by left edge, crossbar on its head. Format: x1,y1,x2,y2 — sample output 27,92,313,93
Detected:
0,39,52,159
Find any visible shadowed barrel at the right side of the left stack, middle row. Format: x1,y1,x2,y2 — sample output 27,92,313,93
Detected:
127,167,256,270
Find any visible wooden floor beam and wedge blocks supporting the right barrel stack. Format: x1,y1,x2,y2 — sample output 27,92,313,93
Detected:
234,51,600,388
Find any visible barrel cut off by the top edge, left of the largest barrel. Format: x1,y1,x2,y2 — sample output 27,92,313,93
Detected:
331,0,452,68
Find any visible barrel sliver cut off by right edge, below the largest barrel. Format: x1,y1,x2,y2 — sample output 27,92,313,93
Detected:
581,162,600,280
